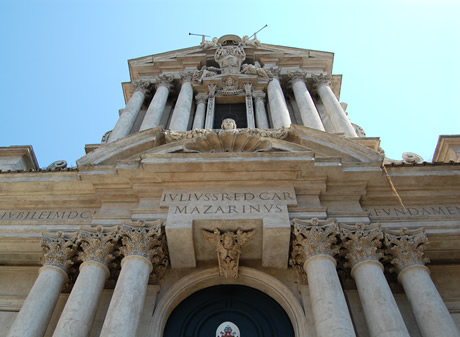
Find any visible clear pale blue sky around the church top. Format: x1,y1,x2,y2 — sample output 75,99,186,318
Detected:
0,0,460,167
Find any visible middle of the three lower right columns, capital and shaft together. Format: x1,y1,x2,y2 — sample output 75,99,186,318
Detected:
341,224,410,337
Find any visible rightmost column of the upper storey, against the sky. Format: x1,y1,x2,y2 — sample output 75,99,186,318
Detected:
312,75,357,137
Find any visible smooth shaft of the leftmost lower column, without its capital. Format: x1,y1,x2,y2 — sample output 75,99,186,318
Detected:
7,266,67,337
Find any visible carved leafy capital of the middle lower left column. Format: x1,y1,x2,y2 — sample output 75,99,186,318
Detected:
77,226,119,266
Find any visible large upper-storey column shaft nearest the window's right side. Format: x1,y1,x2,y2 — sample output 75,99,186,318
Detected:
267,72,291,129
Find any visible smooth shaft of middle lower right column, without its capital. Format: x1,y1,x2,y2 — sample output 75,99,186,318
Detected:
352,260,410,337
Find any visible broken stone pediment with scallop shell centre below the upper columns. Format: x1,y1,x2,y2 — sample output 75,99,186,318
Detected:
77,124,383,167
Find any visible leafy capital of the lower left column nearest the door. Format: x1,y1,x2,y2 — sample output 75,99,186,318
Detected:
119,220,162,262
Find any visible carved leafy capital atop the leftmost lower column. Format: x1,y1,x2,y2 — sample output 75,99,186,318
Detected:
40,232,77,273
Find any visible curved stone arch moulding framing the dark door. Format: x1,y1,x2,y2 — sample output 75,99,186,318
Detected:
150,267,314,337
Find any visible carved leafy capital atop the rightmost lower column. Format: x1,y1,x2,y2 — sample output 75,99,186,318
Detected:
384,228,430,273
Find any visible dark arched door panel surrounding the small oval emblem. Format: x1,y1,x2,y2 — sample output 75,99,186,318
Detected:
163,285,294,337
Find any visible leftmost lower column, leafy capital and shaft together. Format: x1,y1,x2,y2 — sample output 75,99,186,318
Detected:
7,232,76,337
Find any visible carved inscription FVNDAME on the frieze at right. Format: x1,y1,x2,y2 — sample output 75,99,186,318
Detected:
367,206,460,217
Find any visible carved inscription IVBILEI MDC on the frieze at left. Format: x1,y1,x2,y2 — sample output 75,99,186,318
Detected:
0,210,96,221
